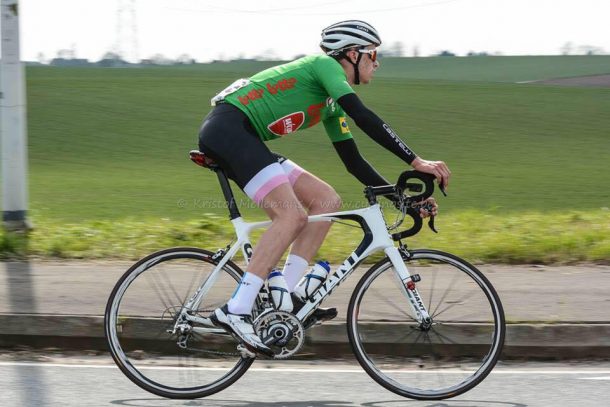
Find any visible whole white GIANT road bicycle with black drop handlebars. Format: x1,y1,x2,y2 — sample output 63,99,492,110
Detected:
104,151,506,400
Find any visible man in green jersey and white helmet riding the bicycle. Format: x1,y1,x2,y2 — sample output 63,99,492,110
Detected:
199,20,450,355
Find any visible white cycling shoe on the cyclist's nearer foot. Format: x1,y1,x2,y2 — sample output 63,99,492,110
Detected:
210,304,275,357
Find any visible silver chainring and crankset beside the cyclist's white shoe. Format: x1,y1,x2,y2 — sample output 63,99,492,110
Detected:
254,311,305,359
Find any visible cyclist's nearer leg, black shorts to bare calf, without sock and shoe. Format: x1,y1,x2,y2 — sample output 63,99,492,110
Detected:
200,108,307,286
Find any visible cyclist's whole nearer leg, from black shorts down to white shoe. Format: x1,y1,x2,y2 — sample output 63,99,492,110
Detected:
199,104,307,353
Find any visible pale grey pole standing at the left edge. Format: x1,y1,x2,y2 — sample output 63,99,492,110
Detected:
0,0,29,231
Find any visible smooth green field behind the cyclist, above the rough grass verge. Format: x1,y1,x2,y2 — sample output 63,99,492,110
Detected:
0,57,610,257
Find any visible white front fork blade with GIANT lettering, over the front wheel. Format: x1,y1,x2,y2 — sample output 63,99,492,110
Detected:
384,245,432,330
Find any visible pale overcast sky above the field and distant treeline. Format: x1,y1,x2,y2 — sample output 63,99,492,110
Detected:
20,0,610,61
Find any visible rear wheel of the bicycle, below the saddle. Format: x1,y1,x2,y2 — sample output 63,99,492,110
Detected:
104,248,254,398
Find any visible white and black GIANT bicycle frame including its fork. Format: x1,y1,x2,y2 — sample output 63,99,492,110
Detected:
182,203,430,333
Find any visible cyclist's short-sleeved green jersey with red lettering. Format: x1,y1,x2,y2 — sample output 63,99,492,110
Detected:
212,55,354,142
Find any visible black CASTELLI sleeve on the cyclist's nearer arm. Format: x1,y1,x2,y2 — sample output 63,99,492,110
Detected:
337,93,417,164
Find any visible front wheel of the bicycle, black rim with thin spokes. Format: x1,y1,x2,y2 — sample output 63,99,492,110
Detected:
348,250,506,400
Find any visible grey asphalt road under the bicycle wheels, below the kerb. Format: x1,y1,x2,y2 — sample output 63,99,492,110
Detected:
0,355,610,407
